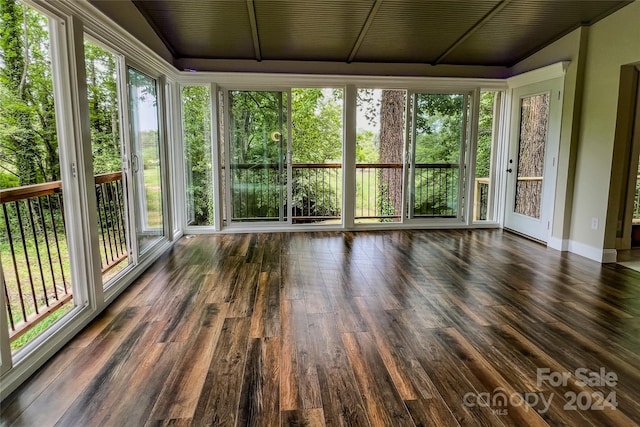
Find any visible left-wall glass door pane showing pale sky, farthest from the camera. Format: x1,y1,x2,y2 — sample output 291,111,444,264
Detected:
128,68,164,254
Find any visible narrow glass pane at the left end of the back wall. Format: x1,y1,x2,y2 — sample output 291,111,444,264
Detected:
182,86,214,225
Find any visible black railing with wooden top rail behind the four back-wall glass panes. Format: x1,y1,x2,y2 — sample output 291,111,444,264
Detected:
232,163,459,223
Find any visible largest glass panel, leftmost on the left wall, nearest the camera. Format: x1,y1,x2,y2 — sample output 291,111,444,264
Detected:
0,2,75,352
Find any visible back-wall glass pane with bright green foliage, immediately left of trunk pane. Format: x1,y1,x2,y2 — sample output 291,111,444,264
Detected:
291,88,343,224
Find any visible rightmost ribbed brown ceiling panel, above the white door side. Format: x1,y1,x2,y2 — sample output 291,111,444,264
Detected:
441,0,624,66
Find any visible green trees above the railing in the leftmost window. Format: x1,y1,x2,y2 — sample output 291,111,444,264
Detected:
0,0,60,185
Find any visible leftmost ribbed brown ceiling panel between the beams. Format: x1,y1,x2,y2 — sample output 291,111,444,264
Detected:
135,0,255,59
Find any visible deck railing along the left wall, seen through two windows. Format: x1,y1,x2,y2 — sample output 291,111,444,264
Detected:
0,172,127,342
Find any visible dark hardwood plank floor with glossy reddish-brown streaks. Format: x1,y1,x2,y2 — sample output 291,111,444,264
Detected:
2,230,640,427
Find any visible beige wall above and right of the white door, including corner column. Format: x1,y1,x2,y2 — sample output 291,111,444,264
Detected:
509,0,640,261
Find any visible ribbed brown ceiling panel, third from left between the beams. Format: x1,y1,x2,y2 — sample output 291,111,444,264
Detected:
354,0,499,63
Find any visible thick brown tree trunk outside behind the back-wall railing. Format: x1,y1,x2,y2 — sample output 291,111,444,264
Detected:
378,90,405,215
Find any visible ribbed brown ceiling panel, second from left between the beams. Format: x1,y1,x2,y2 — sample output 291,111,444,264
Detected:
255,0,372,62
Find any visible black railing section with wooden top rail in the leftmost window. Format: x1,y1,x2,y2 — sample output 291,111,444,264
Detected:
0,181,71,341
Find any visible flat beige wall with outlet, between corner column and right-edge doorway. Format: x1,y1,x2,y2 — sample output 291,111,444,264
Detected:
570,1,640,260
